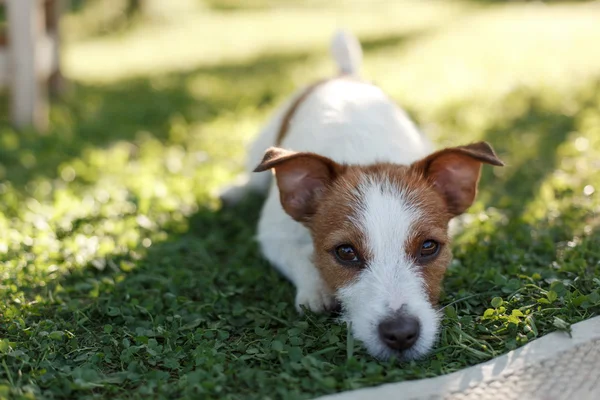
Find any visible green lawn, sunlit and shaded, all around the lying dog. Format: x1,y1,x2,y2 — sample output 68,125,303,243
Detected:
0,1,600,399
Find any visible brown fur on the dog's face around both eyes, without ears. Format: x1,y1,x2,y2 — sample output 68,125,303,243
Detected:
307,164,451,304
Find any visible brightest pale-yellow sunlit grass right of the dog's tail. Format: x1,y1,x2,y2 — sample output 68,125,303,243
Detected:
366,3,600,112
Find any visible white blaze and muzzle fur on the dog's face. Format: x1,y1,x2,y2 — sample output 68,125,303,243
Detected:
338,179,439,358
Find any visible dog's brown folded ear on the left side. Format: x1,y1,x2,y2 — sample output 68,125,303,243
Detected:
254,147,344,222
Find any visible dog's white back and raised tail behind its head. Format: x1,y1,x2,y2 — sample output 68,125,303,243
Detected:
278,32,432,164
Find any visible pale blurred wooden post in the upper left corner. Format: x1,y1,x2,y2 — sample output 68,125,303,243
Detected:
6,0,48,131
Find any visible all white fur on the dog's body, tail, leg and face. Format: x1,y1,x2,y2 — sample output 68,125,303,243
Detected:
222,30,437,357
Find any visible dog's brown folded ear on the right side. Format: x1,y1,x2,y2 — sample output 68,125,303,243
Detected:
411,142,504,216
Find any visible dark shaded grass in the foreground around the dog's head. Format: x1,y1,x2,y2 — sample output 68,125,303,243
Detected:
3,198,600,398
